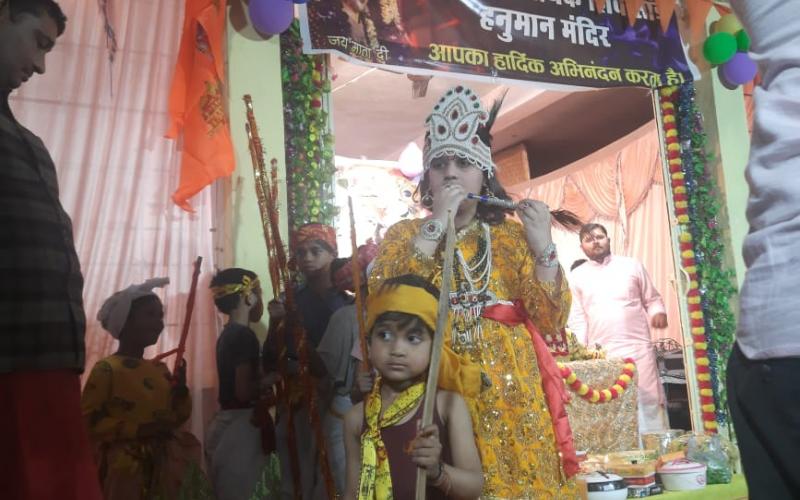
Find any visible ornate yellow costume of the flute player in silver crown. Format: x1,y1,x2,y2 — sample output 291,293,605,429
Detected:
370,220,577,499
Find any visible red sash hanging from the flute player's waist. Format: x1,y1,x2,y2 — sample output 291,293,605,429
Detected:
482,300,580,477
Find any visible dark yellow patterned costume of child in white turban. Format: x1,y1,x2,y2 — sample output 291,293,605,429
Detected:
81,355,207,500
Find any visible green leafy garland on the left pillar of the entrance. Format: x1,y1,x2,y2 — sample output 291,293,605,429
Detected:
281,20,337,229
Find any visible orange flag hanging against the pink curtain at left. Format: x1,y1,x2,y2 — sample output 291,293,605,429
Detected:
167,0,236,212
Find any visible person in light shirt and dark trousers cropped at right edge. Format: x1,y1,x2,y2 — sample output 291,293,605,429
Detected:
728,0,800,500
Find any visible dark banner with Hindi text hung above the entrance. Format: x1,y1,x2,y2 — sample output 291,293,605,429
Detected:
301,0,692,88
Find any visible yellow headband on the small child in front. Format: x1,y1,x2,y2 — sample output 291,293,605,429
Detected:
367,285,439,332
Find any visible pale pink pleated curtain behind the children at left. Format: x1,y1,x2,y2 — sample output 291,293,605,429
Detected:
11,0,218,439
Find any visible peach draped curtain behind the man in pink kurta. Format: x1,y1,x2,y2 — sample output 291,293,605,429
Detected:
509,122,683,345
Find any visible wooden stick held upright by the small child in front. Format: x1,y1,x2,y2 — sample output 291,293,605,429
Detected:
416,210,456,500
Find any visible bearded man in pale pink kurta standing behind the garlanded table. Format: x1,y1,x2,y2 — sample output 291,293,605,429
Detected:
569,224,668,433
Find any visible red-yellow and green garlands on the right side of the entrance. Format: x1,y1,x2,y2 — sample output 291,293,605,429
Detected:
660,84,736,433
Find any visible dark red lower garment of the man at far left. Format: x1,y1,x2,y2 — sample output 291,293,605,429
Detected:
0,370,103,500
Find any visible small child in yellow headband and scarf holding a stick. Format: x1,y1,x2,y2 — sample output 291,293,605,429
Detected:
344,275,483,500
